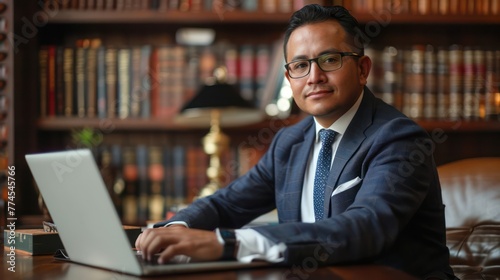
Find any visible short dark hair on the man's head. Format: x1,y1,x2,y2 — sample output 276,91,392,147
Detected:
283,4,364,60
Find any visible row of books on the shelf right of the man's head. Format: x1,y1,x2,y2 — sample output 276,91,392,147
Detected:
366,45,500,120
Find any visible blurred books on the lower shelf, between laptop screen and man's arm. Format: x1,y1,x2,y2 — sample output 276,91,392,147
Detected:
94,143,263,224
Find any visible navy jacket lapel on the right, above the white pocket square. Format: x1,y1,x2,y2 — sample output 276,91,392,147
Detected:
324,87,374,213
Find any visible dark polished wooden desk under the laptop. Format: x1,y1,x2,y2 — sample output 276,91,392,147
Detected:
0,248,415,280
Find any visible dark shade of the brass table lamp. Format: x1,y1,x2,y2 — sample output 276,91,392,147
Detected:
176,84,263,127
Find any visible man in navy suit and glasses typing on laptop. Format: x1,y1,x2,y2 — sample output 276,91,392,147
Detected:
136,5,453,279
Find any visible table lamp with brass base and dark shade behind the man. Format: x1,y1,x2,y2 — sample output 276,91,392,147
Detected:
176,67,263,197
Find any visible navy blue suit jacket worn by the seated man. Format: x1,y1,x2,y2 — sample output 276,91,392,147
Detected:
159,88,453,279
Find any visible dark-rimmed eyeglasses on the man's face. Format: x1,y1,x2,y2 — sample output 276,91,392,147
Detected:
285,52,362,79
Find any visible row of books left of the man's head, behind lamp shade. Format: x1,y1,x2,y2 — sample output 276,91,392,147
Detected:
39,39,273,119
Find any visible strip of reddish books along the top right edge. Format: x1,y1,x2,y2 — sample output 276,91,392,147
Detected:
351,0,500,15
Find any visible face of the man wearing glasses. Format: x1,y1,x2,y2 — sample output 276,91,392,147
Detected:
285,20,371,127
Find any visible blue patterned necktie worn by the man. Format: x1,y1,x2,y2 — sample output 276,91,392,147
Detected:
313,129,336,221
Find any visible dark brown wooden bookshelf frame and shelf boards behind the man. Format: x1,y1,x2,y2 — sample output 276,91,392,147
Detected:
12,0,500,223
